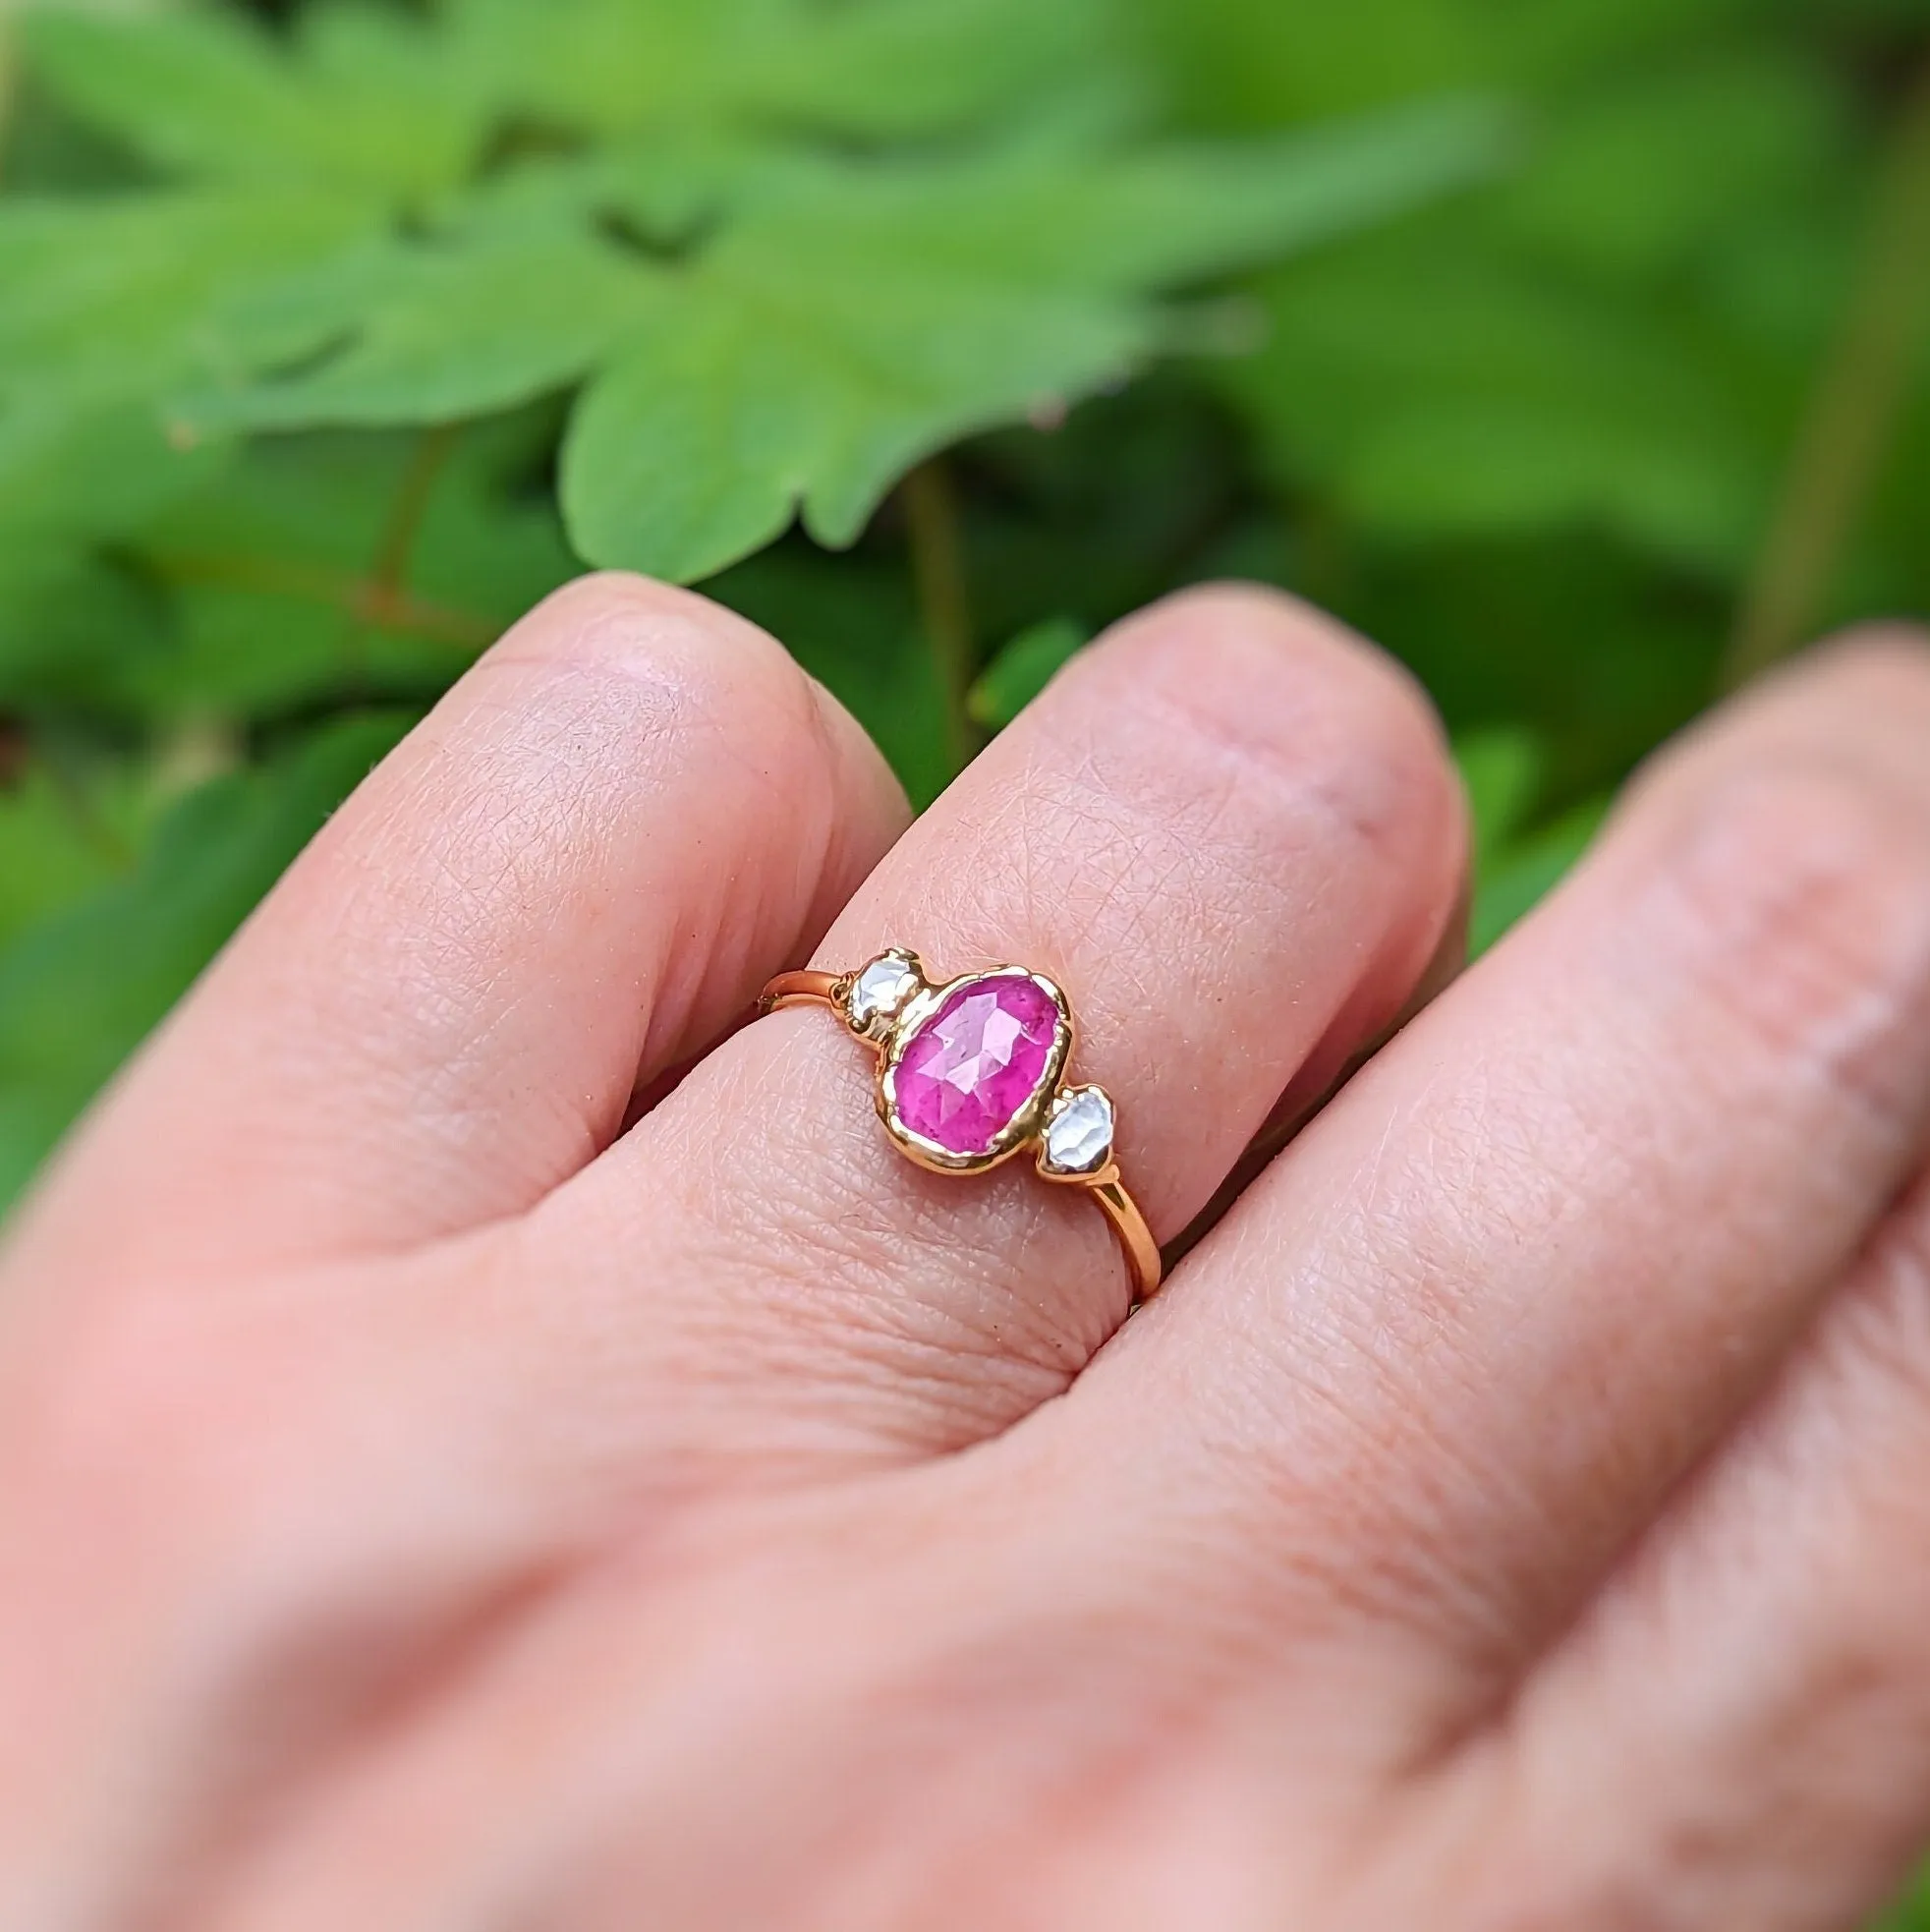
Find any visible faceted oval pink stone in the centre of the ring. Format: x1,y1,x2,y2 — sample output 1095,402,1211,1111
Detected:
896,978,1058,1154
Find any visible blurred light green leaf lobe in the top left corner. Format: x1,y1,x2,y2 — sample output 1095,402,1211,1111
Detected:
28,6,482,200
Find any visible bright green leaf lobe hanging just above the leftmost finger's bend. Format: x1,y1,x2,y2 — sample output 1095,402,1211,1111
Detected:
562,240,1148,582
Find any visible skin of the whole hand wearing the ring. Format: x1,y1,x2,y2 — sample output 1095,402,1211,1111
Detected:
0,578,1930,1932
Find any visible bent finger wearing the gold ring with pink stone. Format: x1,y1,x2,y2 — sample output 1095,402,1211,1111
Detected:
538,590,1462,1448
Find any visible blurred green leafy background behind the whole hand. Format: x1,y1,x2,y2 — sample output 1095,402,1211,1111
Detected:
0,0,1930,1928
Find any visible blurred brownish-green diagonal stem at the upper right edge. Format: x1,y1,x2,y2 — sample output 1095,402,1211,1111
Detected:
1722,72,1930,690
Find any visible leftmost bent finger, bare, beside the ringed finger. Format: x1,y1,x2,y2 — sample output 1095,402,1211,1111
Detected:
3,576,904,1279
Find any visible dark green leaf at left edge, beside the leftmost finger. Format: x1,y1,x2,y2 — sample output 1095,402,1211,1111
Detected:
0,718,402,1202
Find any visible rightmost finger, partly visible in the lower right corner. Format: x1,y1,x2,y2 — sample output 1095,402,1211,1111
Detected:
1421,1178,1930,1932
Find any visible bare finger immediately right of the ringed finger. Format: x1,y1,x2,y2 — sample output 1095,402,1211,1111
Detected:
1048,648,1930,1734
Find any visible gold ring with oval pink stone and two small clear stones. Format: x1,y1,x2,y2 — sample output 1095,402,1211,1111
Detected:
758,946,1162,1304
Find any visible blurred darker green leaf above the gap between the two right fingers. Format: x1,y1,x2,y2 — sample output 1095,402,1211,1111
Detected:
1228,234,1774,568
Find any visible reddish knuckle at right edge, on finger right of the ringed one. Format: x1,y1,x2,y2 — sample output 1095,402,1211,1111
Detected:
1672,766,1930,1120
